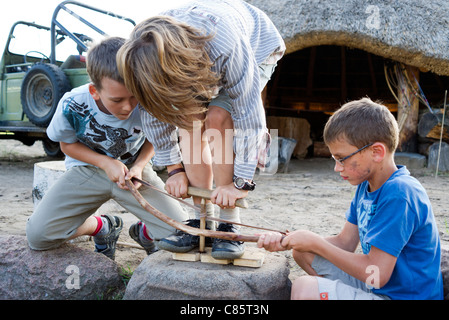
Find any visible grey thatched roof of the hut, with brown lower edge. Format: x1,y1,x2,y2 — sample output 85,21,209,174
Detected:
247,0,449,76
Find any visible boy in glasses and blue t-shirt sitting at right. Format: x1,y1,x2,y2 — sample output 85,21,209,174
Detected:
258,98,443,300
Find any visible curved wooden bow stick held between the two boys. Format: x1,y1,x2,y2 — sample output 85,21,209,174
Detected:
126,180,259,242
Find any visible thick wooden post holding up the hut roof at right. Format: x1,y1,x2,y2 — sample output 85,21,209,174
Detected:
398,66,419,152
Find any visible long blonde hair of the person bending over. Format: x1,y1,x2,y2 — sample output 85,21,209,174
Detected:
117,16,218,129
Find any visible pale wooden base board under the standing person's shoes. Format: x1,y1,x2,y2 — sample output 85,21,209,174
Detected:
173,247,265,268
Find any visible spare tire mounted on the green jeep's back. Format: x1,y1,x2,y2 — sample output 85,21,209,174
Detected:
20,63,71,127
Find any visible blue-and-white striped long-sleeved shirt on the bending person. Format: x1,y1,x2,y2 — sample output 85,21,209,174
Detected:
140,0,285,179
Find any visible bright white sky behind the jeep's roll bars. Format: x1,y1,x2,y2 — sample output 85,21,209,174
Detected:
0,0,187,58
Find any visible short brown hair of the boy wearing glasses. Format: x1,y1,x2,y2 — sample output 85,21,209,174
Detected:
324,98,399,153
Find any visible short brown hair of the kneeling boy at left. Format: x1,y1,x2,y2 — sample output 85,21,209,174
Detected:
86,37,125,91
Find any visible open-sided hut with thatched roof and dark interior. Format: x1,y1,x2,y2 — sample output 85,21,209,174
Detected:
246,0,449,156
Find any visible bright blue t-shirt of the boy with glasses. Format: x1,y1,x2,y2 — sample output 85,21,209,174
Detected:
346,166,443,300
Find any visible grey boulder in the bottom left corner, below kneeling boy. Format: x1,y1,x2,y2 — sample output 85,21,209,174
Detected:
0,235,124,300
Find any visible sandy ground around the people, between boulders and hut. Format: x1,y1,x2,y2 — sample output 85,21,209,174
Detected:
0,140,449,279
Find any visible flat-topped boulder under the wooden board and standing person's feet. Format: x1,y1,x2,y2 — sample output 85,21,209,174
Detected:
124,251,291,300
